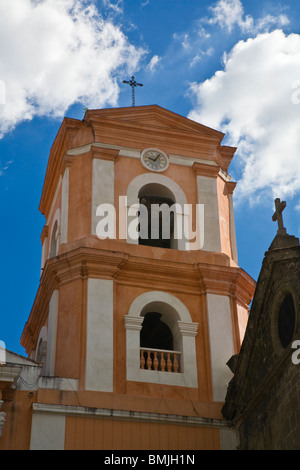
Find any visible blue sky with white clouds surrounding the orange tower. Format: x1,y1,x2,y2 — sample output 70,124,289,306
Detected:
0,0,300,354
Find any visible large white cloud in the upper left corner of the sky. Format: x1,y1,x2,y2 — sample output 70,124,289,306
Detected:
0,0,144,136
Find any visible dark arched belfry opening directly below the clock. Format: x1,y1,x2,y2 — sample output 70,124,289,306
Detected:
138,183,175,248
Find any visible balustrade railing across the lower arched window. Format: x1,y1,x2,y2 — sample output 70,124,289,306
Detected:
140,348,181,372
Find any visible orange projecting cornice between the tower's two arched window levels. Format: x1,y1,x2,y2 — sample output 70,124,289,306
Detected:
21,246,255,353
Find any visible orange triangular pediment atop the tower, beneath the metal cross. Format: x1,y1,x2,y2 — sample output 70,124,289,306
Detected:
85,105,224,142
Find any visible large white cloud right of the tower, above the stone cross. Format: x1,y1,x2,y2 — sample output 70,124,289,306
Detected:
189,30,300,201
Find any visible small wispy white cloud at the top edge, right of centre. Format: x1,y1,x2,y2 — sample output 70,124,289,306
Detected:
208,0,289,34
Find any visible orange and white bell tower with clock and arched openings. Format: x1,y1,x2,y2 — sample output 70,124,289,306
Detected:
21,105,255,450
